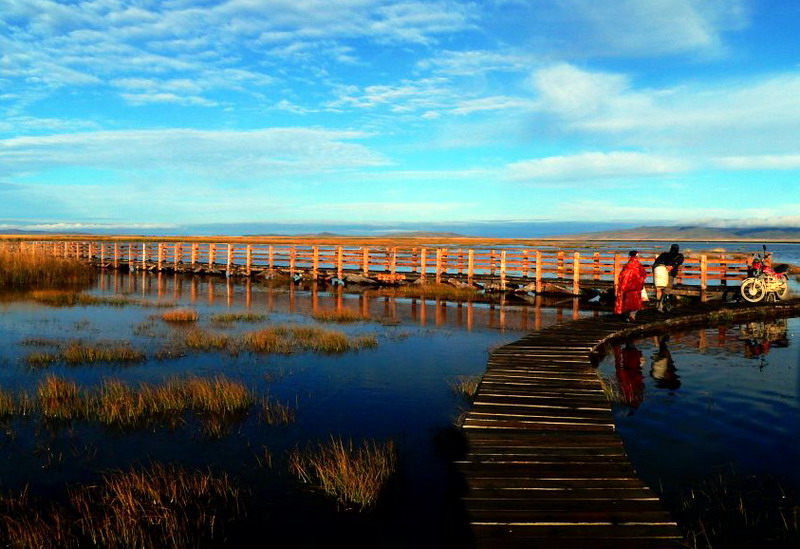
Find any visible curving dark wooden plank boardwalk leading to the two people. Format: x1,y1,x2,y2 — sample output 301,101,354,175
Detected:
456,300,800,549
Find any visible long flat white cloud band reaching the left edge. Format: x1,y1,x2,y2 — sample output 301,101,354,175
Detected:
0,128,387,181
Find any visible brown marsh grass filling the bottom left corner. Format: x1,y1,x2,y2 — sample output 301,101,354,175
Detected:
0,463,243,549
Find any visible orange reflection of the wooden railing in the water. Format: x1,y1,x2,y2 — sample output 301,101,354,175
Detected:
98,271,600,332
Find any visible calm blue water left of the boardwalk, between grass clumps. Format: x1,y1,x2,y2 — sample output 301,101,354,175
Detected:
0,273,593,547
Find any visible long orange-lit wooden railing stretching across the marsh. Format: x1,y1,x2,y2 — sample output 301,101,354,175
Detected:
20,240,748,295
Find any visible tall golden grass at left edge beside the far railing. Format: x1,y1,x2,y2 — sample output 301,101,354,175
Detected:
0,248,94,290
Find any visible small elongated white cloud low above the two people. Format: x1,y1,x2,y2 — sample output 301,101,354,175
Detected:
507,152,691,182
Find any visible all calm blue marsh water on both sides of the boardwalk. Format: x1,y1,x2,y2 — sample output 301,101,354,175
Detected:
0,256,800,547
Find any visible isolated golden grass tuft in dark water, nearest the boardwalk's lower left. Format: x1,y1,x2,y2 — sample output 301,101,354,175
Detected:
289,436,397,511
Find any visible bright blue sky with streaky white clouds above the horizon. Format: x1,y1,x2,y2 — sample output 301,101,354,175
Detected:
0,0,800,234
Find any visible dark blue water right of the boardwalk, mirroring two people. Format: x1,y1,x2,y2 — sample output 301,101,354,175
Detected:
600,318,800,508
